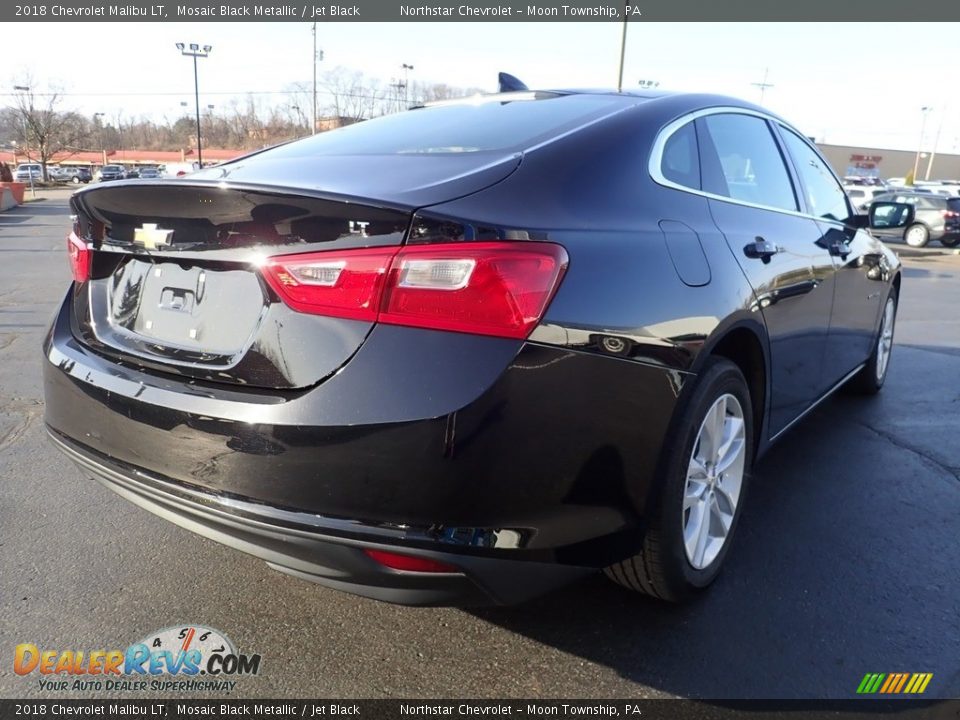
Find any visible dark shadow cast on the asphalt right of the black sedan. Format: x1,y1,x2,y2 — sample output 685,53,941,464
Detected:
471,390,960,699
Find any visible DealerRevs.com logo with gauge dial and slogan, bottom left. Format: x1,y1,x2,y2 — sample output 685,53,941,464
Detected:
13,625,260,693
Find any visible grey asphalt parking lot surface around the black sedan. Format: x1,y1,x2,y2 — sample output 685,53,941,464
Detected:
0,192,960,699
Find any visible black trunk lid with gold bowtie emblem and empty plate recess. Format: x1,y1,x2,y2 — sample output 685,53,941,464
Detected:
73,153,516,389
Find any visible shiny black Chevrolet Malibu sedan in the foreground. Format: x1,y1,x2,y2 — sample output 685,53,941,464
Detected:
44,91,912,604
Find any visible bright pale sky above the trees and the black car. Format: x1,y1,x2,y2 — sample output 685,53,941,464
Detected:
0,22,960,152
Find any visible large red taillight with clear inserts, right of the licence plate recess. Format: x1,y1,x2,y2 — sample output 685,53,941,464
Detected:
263,242,568,339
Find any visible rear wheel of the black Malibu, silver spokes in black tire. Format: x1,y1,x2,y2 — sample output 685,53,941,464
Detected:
604,358,753,602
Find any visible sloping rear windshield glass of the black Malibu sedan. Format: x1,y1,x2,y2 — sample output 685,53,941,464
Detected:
258,95,628,157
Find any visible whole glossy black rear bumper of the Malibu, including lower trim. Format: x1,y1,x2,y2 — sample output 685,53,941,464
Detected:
44,286,685,604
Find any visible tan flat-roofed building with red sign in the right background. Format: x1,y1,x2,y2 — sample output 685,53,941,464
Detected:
817,143,960,180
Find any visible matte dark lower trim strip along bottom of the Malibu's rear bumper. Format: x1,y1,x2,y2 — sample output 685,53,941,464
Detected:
48,427,593,605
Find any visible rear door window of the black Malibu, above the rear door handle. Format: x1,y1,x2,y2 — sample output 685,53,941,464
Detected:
698,113,797,211
